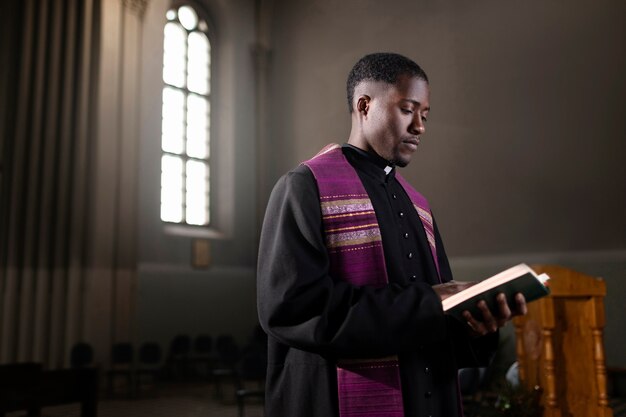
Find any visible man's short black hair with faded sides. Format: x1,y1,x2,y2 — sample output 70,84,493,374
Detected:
346,52,428,113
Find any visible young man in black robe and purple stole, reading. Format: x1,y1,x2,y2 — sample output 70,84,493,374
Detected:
258,53,526,417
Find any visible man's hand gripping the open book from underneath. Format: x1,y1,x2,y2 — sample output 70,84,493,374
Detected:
463,293,528,336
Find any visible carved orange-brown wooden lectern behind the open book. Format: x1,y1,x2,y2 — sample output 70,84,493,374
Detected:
513,265,613,417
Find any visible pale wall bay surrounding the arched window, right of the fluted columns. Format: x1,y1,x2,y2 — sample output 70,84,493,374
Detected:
136,0,257,348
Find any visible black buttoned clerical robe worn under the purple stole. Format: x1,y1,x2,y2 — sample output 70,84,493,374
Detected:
257,145,497,417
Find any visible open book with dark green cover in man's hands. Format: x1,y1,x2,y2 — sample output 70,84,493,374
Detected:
442,264,550,321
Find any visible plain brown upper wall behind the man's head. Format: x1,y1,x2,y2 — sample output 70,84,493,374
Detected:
268,0,626,256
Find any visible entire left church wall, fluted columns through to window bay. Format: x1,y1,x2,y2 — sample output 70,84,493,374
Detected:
0,0,258,368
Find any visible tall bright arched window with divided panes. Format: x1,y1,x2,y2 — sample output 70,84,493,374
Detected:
161,5,211,226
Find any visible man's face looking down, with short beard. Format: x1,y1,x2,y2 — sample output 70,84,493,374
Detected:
362,76,430,167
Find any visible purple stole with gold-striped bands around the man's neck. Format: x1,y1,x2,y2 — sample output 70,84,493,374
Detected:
304,144,441,417
